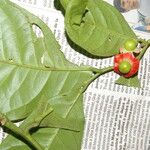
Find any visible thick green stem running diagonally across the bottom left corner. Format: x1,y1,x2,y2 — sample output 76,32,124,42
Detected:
0,113,44,150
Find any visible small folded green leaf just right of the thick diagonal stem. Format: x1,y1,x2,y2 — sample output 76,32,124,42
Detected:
17,96,80,132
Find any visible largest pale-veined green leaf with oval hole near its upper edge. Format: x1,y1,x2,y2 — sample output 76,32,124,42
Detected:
0,1,93,119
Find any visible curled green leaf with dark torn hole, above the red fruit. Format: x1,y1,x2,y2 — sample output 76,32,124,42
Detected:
65,0,136,57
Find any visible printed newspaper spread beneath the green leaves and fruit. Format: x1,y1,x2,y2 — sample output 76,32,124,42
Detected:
0,0,150,150
